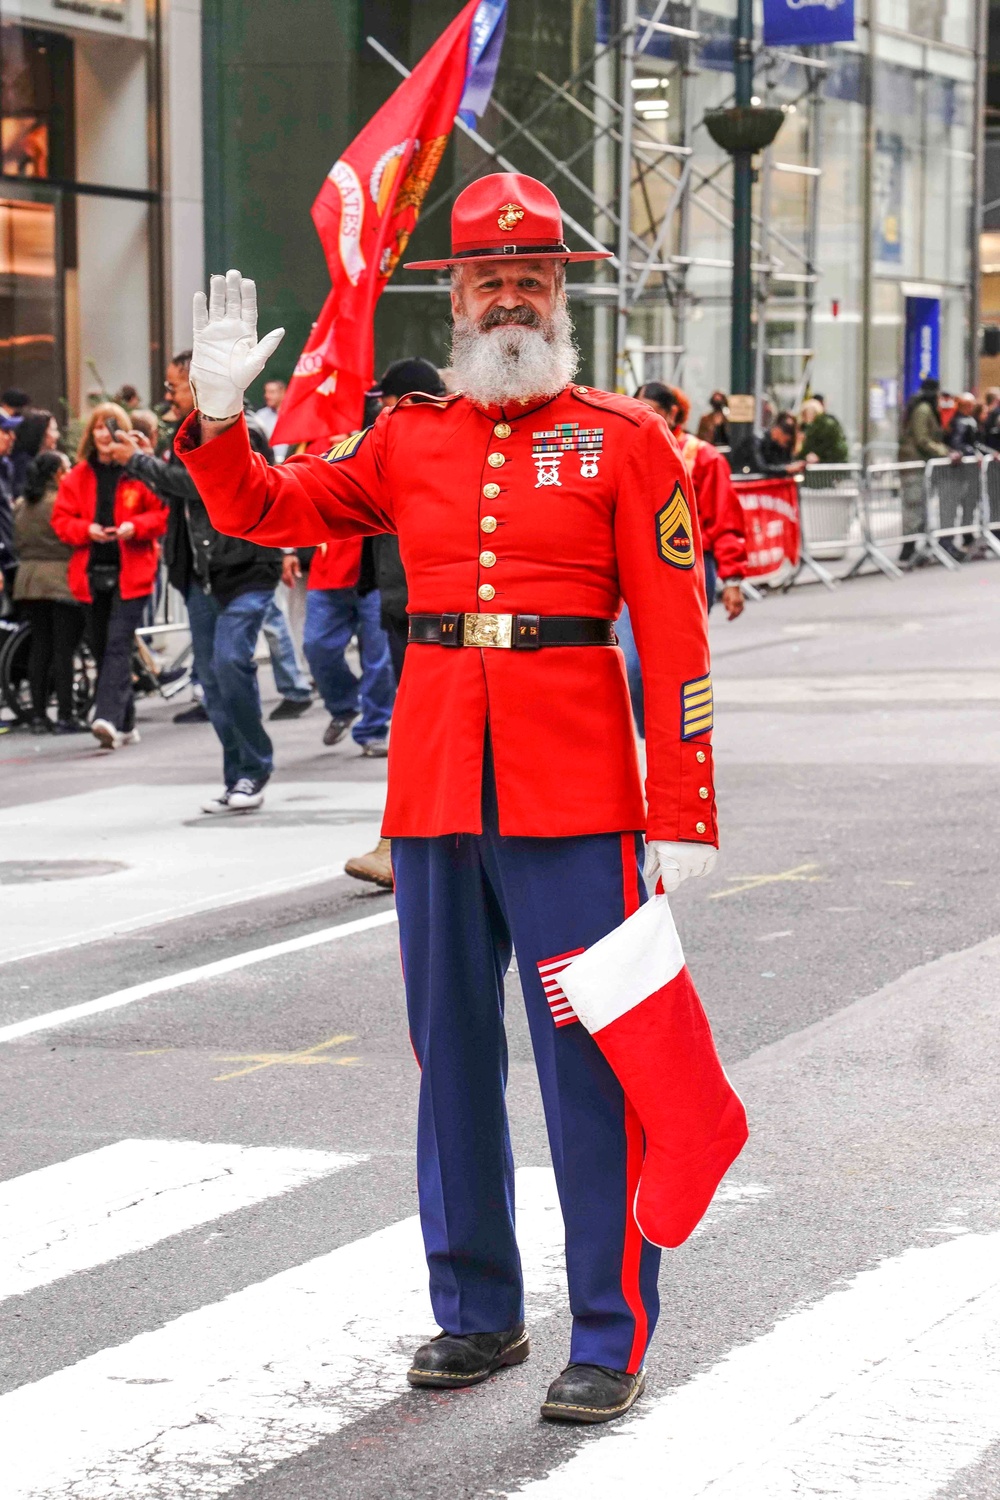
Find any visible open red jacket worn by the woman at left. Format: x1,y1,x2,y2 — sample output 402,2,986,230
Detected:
52,461,168,605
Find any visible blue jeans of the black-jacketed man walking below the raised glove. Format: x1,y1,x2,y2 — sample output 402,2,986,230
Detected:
187,585,274,786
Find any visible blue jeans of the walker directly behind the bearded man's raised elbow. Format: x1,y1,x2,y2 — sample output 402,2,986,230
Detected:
303,588,396,746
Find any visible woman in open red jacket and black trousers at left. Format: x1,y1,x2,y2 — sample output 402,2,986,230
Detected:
52,401,166,750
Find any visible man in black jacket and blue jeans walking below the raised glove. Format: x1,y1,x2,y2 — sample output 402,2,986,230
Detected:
110,350,282,813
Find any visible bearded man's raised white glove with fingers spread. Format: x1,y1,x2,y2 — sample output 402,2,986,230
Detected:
189,272,285,417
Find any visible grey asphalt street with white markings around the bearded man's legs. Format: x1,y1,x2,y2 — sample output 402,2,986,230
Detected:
0,563,1000,1500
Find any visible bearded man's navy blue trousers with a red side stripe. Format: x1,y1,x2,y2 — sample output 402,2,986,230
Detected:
393,762,660,1371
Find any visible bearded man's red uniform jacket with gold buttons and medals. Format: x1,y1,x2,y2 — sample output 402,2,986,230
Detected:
175,386,717,843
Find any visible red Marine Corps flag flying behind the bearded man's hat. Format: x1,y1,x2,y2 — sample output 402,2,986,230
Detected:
271,0,507,443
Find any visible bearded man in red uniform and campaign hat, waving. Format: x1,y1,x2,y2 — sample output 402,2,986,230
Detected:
180,174,717,1422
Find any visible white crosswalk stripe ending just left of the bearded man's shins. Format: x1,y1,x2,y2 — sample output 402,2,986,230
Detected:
0,1140,359,1299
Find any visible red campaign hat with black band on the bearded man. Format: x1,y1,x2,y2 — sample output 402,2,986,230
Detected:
405,173,612,272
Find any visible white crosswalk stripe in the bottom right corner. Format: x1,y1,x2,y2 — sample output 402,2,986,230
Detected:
513,1233,1000,1500
